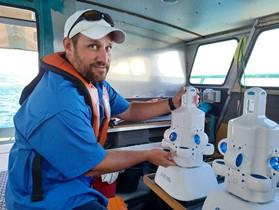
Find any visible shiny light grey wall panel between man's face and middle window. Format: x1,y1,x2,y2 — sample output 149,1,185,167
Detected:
108,46,186,98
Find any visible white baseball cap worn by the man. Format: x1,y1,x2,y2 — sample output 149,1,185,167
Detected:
64,9,125,43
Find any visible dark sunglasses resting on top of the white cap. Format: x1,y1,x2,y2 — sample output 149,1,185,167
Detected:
67,10,114,37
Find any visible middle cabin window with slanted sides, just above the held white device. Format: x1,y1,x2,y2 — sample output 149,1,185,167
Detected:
190,39,237,85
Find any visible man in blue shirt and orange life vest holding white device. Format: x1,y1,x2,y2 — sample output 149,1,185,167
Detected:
6,10,185,210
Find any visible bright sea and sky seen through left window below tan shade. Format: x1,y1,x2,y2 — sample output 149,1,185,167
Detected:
0,48,38,128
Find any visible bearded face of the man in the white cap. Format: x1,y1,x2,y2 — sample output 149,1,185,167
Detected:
65,34,112,83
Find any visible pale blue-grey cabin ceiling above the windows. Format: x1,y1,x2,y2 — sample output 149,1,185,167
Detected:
82,0,279,42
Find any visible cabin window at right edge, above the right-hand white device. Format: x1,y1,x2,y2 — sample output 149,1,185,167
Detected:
241,29,279,87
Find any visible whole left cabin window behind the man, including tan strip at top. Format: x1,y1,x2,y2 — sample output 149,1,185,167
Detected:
0,6,38,143
